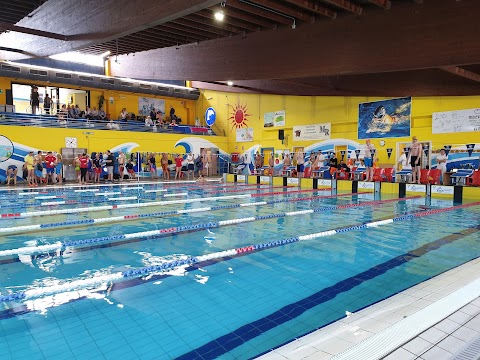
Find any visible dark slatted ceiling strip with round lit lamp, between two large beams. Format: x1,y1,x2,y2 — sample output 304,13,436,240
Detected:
82,0,404,55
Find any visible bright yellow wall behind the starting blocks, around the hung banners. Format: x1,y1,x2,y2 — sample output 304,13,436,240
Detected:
195,90,480,163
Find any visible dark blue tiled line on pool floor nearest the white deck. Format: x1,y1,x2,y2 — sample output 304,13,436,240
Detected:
176,225,480,360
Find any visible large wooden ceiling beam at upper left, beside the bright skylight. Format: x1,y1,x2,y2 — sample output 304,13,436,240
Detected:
0,0,220,60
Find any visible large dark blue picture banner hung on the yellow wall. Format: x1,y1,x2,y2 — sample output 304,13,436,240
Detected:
358,96,412,140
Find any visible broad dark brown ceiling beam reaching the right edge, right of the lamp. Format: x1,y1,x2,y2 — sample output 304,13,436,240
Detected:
112,0,480,81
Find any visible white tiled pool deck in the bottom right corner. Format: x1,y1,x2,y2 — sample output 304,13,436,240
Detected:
258,259,480,360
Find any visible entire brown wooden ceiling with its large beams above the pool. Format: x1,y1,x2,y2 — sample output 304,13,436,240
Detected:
0,0,480,96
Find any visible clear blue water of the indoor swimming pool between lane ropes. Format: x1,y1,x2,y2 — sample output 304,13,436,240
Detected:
0,184,480,360
